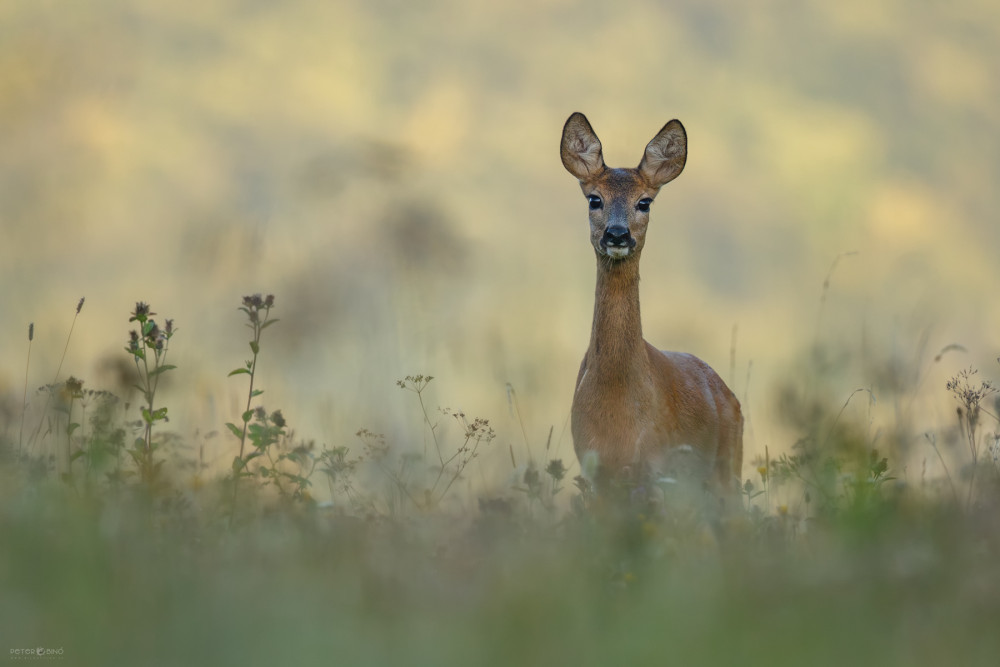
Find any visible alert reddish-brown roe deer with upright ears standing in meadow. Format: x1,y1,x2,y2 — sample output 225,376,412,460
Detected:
560,113,743,502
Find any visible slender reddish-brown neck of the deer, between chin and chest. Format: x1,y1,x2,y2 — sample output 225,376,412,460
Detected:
587,255,649,383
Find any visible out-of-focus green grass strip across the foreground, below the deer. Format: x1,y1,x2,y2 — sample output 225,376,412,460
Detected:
0,480,1000,665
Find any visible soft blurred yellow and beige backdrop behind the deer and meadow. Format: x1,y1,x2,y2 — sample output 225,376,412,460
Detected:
0,0,1000,490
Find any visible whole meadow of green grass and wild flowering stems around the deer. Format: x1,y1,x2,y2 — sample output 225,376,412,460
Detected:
0,296,1000,665
